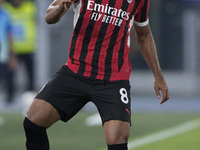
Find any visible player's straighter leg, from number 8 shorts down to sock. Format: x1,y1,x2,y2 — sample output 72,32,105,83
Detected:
92,81,131,150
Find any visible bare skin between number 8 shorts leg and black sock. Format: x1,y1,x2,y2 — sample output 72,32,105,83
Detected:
103,120,130,145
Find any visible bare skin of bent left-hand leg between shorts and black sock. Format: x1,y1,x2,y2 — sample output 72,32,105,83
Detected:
27,99,60,128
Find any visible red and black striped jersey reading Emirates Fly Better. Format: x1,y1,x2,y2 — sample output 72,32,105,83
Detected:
66,0,150,81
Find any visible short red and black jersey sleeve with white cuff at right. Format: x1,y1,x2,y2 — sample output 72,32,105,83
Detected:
134,0,150,27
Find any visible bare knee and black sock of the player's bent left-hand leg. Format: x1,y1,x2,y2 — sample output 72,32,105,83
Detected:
24,99,60,150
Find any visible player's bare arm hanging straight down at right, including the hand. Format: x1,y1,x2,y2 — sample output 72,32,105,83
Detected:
134,24,169,104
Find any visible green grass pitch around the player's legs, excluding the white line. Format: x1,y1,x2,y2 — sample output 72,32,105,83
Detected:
0,111,200,150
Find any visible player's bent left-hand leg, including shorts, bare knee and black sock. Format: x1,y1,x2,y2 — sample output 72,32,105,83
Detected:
24,66,89,150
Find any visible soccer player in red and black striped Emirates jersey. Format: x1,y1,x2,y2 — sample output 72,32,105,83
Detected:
24,0,169,150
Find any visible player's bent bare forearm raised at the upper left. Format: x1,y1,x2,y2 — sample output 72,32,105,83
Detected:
45,0,74,24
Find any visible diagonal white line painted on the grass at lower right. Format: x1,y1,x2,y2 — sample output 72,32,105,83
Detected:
128,120,200,149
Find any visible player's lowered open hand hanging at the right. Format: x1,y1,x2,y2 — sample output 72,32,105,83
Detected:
154,78,169,104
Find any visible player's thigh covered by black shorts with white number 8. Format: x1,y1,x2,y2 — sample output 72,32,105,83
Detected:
92,81,131,124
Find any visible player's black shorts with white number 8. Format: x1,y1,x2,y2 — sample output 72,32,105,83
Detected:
36,66,131,123
